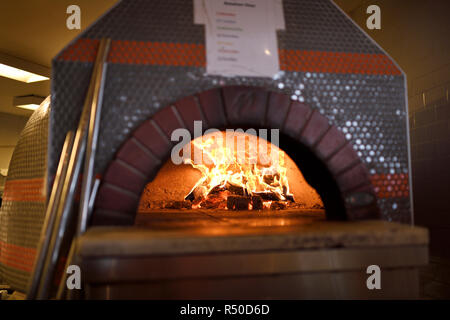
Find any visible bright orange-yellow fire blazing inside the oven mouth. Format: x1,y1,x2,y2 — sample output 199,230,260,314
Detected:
186,131,293,209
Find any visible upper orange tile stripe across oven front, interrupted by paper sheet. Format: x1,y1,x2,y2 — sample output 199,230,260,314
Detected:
58,39,401,75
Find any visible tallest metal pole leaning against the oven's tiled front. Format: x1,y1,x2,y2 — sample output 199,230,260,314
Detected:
37,39,110,299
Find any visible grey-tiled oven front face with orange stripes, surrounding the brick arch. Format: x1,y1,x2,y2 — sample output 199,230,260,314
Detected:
48,0,412,223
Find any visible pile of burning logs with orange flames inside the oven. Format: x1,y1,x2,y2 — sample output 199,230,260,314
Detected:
185,131,294,210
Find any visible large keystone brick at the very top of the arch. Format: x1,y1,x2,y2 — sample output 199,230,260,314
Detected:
222,86,268,127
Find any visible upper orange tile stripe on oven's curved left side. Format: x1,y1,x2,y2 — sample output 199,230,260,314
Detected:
3,178,46,202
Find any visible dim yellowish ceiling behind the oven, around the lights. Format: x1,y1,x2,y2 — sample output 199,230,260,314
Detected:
0,0,366,116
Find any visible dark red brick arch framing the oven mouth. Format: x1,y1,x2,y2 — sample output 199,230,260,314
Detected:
92,86,378,225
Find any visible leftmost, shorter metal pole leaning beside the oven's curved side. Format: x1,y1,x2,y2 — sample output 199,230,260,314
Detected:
27,131,74,300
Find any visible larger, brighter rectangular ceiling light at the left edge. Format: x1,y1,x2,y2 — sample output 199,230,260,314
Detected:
0,53,50,83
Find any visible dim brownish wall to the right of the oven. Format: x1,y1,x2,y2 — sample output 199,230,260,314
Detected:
338,0,450,258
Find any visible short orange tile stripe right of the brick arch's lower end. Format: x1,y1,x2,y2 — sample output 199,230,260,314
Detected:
371,173,409,198
